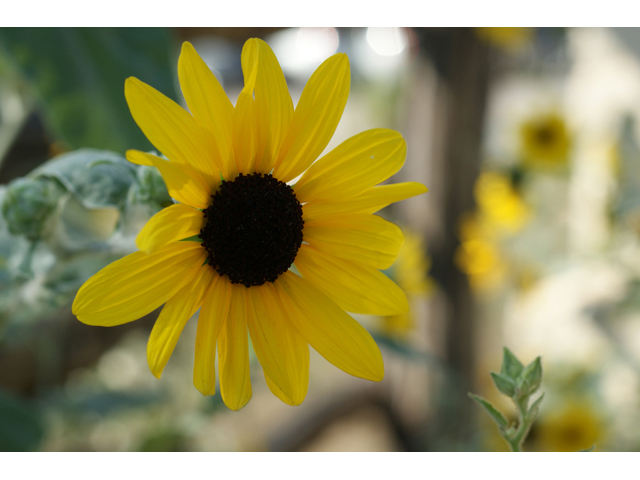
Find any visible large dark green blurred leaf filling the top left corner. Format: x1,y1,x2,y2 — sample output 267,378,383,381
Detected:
0,28,176,151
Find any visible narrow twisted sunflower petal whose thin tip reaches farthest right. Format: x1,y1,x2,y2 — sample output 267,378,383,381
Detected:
302,182,427,222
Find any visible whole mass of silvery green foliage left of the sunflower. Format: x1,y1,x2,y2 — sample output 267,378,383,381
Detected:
0,149,171,327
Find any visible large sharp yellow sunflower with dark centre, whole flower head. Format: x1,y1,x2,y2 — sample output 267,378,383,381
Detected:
73,39,426,410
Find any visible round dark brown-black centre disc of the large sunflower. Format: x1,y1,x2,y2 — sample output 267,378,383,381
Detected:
200,173,304,287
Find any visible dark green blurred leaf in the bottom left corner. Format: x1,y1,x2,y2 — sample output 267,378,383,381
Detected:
0,390,44,452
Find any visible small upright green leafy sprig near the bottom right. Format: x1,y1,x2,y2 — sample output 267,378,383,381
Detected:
469,347,544,452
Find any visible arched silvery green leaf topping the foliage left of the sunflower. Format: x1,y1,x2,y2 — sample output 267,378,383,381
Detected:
29,148,136,208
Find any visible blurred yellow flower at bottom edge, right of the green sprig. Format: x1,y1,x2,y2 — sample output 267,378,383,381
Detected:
535,400,604,452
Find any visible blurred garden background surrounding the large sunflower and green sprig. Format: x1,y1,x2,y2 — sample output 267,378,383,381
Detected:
0,28,640,451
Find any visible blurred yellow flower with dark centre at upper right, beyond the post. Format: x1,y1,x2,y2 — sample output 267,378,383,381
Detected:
520,113,571,168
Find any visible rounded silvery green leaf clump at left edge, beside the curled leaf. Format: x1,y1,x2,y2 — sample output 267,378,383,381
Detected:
2,178,64,241
